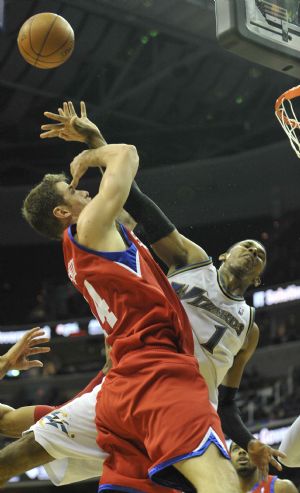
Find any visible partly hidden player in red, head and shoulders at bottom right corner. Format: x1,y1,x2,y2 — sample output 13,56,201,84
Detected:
230,442,298,493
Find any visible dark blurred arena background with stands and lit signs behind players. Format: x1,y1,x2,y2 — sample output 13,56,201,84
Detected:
0,0,300,493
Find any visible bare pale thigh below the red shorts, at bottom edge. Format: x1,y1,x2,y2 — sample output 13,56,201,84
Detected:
174,444,239,493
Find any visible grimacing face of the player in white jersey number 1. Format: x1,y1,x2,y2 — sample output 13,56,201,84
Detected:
226,240,266,279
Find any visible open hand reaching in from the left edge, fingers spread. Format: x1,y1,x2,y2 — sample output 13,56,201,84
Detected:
0,327,50,377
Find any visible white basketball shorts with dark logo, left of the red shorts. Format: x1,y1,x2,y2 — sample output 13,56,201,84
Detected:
25,383,108,486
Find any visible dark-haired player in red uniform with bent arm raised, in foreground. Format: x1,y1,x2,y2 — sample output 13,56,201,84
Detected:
2,100,238,493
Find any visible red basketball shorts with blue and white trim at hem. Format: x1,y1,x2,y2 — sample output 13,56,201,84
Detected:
96,348,229,493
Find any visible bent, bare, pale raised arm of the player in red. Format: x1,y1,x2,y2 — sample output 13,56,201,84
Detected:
70,144,139,250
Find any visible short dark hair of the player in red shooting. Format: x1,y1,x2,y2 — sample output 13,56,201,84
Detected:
22,173,67,240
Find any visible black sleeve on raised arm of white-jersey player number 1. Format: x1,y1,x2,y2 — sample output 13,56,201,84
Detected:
124,181,176,244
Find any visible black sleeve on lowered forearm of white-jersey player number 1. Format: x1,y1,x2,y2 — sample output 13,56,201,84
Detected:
218,385,255,450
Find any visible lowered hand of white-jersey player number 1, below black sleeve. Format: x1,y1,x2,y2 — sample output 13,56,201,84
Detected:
247,439,286,479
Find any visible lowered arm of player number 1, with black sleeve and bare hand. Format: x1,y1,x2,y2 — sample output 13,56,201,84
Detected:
218,323,283,477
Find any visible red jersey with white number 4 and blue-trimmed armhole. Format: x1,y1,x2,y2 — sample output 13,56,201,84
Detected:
63,225,194,365
